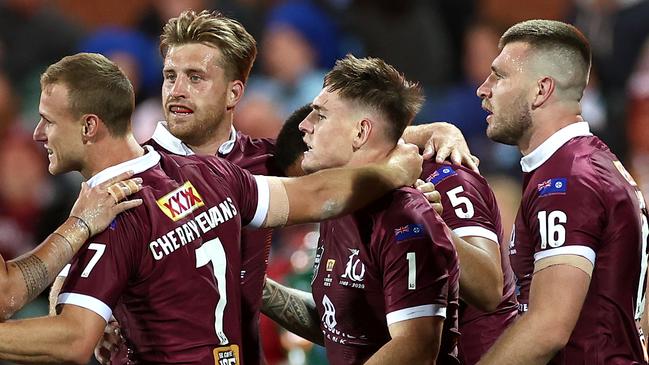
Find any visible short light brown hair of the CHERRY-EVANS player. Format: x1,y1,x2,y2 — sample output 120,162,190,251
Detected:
41,53,135,136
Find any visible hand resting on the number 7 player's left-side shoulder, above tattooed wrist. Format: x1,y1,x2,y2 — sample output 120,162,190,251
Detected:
70,171,142,237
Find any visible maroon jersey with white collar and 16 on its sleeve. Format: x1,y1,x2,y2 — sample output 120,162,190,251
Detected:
510,122,647,365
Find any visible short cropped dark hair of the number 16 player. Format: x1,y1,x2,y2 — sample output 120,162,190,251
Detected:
498,19,592,73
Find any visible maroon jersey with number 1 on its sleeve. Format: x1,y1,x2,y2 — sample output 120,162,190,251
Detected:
312,188,459,365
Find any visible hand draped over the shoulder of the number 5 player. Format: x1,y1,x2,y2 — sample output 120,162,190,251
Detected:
424,122,480,173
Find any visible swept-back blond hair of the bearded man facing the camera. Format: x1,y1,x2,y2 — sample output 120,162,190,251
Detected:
160,10,257,83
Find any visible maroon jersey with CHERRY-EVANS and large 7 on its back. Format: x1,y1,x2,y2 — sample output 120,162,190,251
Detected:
59,147,268,365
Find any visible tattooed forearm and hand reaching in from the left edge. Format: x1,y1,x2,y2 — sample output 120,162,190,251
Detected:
0,173,142,322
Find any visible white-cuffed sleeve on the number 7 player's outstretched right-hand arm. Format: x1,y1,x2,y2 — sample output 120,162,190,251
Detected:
205,157,270,228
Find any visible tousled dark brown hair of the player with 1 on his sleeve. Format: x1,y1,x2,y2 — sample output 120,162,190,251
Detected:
324,54,424,142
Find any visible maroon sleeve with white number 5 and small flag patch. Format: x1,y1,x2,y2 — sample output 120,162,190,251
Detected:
427,165,500,243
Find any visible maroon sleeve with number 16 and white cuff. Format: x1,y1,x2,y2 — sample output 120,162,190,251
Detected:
523,174,606,265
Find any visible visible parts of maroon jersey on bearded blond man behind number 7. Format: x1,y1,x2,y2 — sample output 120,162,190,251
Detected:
145,123,284,365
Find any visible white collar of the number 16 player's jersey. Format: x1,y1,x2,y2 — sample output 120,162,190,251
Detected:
521,122,593,172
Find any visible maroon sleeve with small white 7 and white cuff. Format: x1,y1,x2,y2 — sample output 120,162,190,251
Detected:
58,210,146,321
